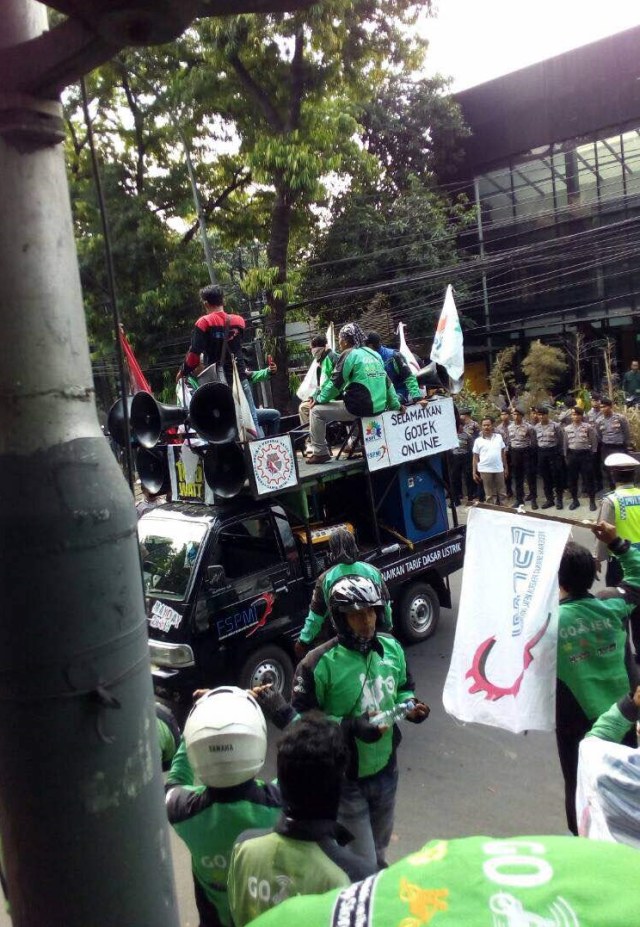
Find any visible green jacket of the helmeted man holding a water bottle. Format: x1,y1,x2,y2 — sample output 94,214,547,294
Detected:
291,634,415,779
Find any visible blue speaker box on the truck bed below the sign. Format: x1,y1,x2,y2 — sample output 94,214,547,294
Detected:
372,456,449,541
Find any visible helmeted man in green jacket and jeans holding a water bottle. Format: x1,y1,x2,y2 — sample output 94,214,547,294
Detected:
291,576,429,868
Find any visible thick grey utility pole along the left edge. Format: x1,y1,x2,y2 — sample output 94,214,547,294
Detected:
0,0,304,927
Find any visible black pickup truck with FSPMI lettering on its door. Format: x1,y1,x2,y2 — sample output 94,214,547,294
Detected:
139,450,465,714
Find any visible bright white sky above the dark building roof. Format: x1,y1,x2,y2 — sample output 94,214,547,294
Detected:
420,0,640,91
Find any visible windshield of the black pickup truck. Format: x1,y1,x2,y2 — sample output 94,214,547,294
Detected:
138,518,207,599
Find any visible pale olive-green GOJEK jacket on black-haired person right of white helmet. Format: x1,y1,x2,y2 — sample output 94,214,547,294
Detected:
228,816,373,927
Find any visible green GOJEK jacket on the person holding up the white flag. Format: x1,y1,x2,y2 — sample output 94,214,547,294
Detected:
556,542,640,727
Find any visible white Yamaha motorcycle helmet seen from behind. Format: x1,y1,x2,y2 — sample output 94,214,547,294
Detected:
184,686,267,789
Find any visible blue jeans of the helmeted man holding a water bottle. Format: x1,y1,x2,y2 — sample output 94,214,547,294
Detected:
338,759,398,868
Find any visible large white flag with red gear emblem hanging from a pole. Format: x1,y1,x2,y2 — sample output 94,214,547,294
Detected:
443,509,570,733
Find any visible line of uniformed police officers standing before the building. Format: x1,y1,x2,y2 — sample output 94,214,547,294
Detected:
450,394,632,512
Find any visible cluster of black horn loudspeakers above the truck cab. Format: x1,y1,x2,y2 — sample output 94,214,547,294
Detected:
108,383,246,499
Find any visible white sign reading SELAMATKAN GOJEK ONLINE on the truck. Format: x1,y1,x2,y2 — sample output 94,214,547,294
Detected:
362,396,458,470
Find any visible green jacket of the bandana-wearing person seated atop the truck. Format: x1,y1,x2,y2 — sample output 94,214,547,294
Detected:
316,348,400,417
